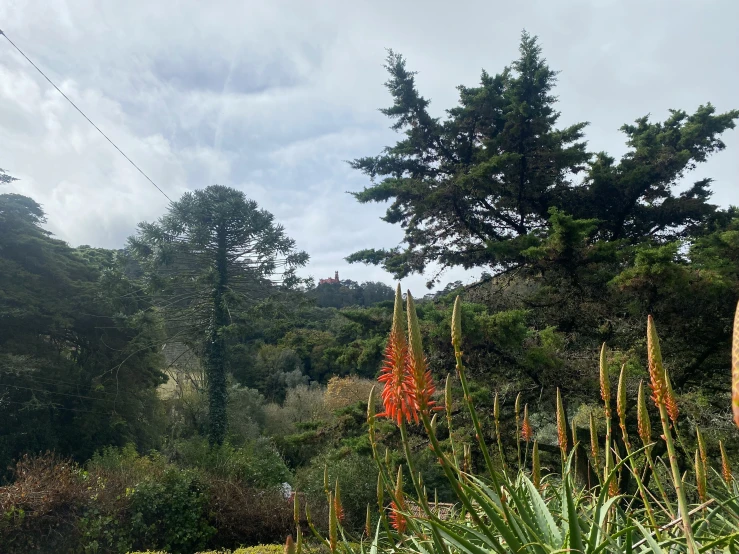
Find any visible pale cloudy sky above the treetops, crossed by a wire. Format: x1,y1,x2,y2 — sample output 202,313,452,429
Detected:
0,0,739,294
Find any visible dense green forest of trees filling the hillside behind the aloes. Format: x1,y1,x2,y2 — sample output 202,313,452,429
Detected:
0,34,739,552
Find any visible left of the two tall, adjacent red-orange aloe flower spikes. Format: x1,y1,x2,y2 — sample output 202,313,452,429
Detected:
377,285,418,425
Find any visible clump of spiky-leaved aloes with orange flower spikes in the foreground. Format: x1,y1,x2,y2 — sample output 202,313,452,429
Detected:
296,287,739,554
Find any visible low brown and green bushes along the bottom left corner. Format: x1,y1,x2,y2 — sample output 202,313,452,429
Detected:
0,441,298,554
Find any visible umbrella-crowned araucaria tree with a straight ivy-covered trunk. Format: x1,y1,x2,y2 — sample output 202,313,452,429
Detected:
129,186,308,444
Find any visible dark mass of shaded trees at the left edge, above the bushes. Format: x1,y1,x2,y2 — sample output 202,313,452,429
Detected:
0,194,168,468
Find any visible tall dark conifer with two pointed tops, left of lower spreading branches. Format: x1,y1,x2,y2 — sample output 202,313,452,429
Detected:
349,32,589,277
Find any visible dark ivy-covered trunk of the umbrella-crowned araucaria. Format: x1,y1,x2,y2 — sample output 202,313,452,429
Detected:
207,229,228,445
